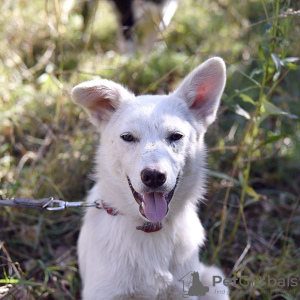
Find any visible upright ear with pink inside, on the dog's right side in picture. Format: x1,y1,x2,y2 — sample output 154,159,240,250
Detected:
174,57,226,128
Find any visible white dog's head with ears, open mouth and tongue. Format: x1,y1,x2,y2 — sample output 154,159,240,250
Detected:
72,58,226,223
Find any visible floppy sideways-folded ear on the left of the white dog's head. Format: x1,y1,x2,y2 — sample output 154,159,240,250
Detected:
71,79,134,127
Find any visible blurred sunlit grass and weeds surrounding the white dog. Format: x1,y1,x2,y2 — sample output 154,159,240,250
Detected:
0,0,300,299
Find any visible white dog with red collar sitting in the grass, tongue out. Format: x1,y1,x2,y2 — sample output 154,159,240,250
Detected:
72,58,229,300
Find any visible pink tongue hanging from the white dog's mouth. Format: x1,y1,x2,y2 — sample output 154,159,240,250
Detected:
143,193,168,222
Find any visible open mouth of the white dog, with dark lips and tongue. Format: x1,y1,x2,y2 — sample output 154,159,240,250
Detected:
127,177,178,223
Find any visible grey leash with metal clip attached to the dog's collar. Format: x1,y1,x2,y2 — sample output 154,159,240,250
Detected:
0,197,102,210
